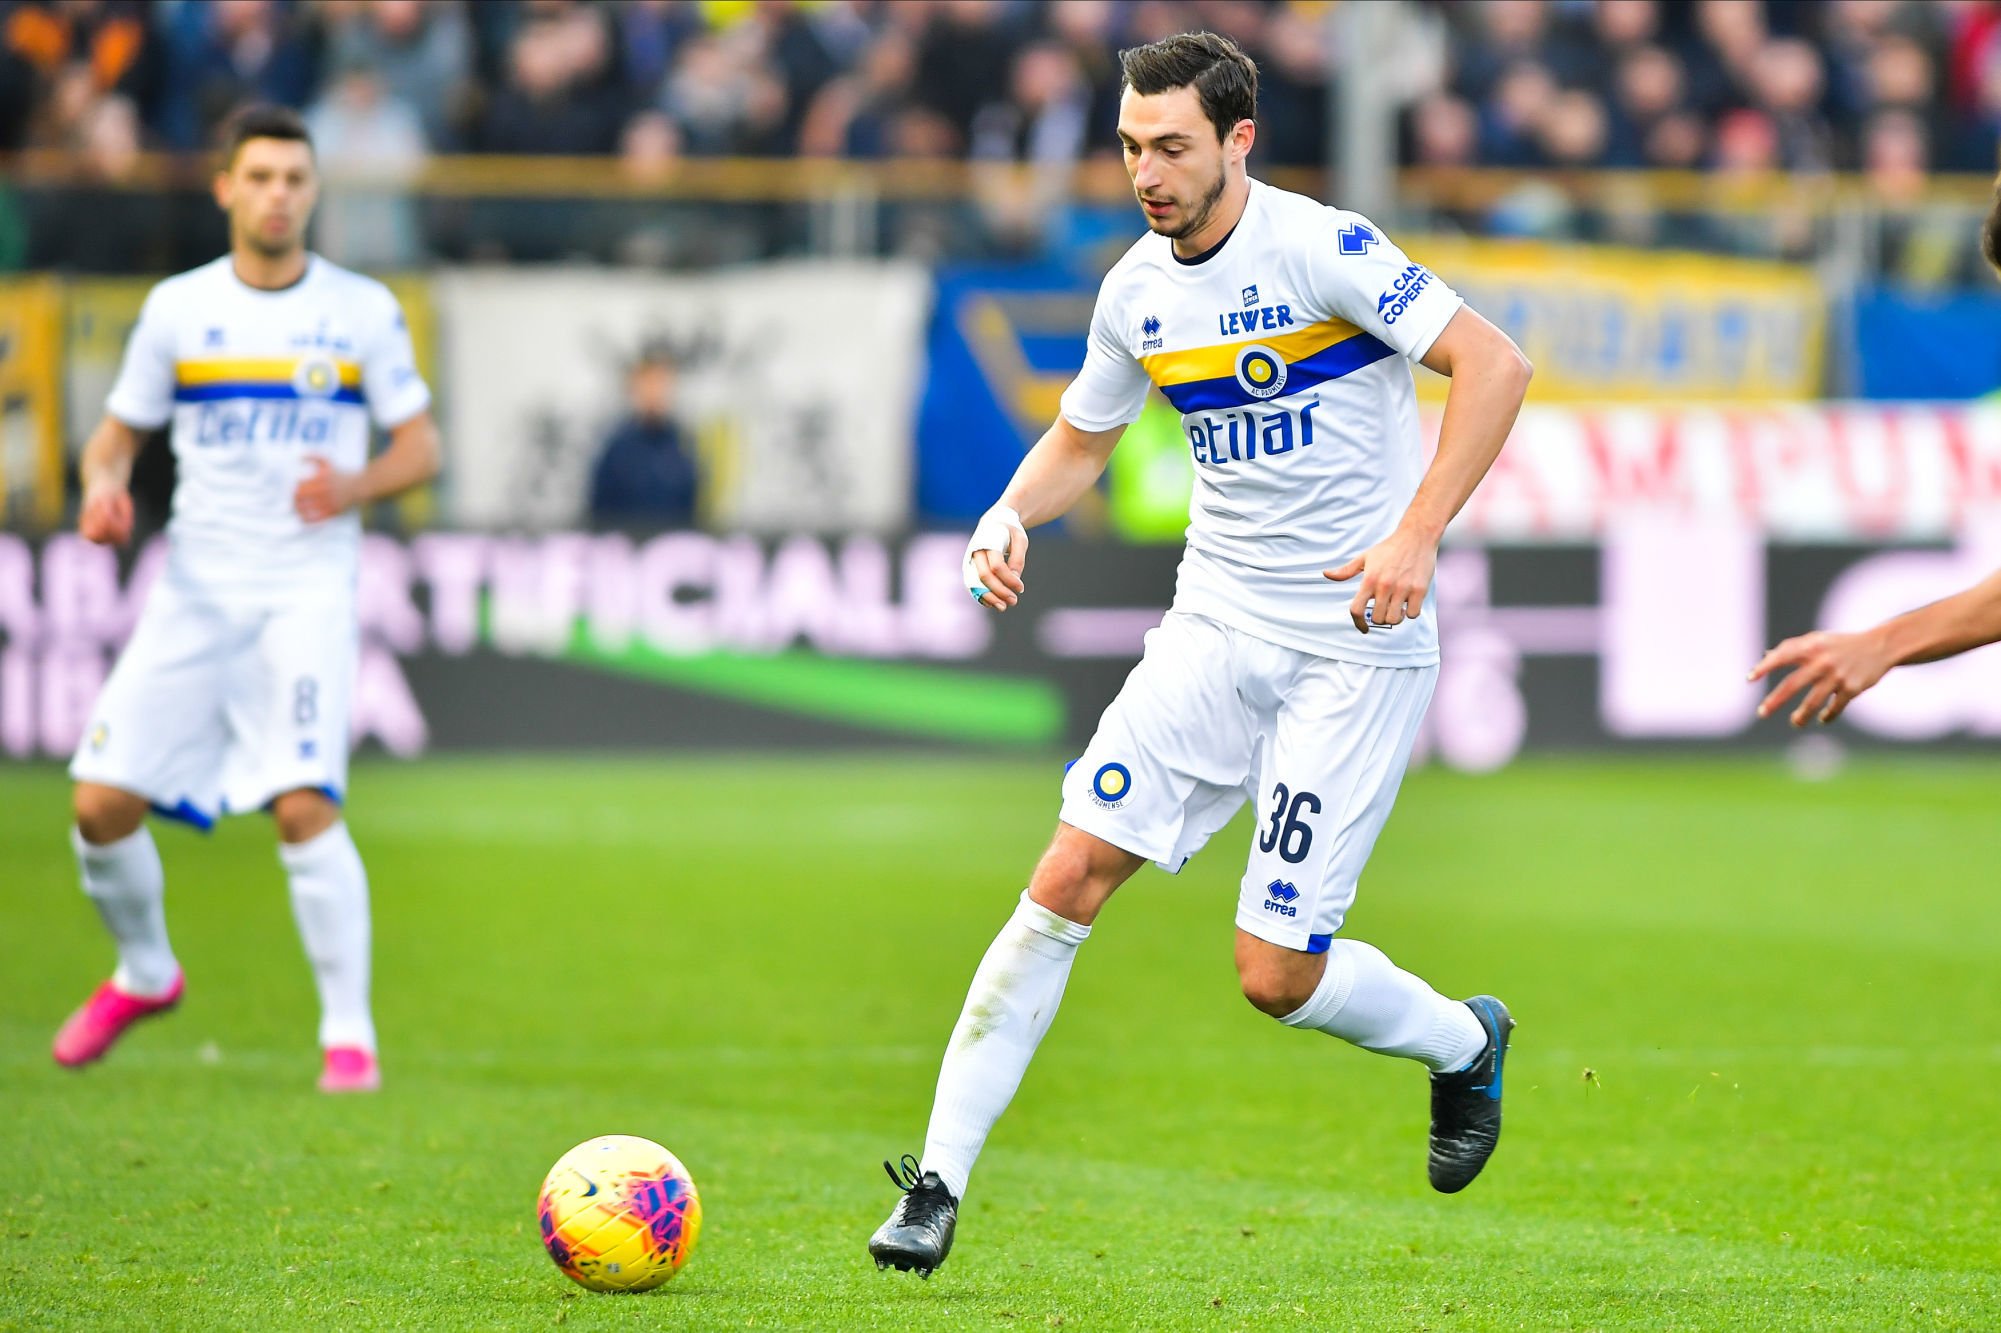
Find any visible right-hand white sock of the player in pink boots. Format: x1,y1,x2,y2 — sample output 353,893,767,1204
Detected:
278,823,376,1051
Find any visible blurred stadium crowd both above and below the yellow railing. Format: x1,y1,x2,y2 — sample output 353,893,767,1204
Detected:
0,0,2001,280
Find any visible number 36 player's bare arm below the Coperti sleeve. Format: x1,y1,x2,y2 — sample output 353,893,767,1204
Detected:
1323,306,1535,634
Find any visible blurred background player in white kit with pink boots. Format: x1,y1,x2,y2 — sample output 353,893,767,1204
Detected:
54,108,438,1093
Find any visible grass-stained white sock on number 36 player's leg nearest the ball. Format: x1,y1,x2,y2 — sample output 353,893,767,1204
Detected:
924,891,1091,1199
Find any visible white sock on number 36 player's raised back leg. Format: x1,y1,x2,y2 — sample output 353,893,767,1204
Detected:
1279,939,1487,1073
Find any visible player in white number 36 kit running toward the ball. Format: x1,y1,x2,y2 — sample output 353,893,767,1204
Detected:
868,32,1531,1277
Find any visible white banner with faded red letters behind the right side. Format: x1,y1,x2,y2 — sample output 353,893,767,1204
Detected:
1427,400,2001,542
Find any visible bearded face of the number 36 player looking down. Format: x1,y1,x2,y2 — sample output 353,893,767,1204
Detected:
1119,88,1251,238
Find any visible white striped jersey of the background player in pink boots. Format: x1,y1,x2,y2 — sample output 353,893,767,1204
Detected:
104,254,430,598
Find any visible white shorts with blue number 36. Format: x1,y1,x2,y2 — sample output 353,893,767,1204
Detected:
1063,610,1439,953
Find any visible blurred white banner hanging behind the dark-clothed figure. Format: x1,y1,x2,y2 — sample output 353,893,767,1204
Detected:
432,262,930,534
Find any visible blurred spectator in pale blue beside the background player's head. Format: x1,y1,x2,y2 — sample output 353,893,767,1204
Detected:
306,64,426,268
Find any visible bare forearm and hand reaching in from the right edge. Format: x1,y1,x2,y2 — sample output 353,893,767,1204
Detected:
1751,570,2001,727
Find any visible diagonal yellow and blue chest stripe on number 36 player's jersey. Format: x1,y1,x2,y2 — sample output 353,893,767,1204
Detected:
1139,320,1395,416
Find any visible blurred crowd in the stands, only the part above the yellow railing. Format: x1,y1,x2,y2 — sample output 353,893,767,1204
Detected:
0,0,2001,170
